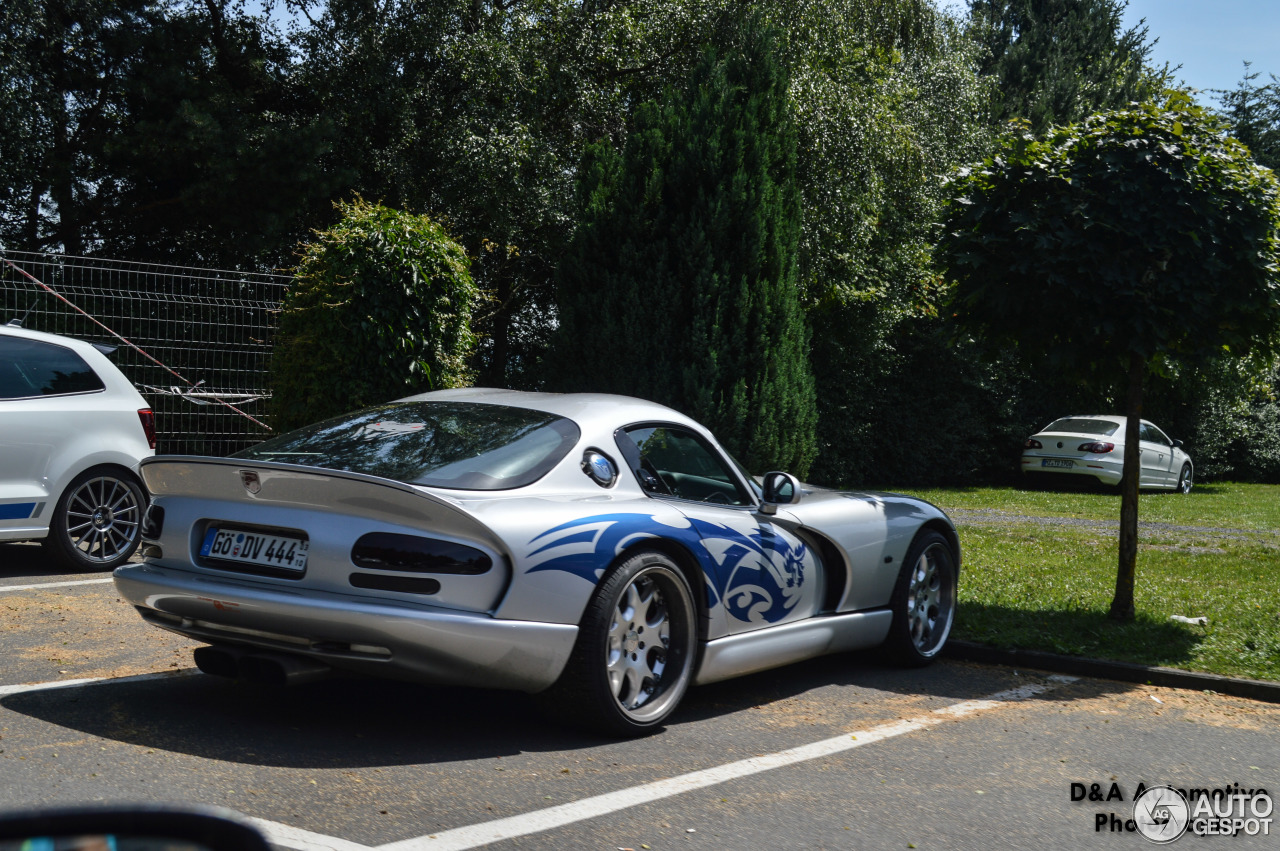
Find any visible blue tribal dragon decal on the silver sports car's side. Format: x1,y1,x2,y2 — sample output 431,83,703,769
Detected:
526,514,815,623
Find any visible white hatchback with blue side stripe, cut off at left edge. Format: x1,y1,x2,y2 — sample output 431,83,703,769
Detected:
0,325,156,571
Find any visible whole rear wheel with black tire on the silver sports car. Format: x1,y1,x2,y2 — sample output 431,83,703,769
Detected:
539,550,698,736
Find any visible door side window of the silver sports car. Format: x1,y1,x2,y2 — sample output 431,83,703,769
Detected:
618,426,753,505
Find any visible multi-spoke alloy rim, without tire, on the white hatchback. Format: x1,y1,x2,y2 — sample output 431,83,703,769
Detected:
60,475,142,566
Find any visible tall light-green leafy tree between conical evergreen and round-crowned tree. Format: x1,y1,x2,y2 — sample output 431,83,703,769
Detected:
762,0,991,486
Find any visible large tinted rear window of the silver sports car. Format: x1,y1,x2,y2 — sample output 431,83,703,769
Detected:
233,402,581,490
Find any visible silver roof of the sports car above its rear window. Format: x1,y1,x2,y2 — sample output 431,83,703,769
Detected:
401,388,705,434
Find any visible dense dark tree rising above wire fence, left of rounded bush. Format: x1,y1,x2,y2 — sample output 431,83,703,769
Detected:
97,0,338,267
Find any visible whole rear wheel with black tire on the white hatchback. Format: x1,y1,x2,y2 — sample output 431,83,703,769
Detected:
45,467,147,571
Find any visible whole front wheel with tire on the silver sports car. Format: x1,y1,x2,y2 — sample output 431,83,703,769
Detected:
884,530,959,667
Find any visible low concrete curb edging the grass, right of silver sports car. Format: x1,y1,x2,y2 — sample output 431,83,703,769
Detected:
942,641,1280,704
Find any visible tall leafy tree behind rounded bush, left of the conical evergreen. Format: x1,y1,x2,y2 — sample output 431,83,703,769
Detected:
284,0,733,385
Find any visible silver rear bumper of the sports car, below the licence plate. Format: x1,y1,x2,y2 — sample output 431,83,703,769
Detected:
115,564,577,692
